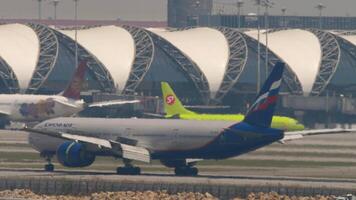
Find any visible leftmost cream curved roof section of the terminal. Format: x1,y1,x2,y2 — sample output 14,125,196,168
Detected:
0,24,40,89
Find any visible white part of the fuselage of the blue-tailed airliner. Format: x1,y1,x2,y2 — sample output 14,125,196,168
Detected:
29,118,232,152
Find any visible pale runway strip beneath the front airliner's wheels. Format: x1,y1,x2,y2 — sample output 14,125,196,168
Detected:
0,168,356,189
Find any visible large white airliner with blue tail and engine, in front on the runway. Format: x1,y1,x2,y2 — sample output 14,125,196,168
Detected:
23,63,354,175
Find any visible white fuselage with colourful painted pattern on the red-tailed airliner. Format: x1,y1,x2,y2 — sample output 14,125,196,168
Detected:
0,94,83,122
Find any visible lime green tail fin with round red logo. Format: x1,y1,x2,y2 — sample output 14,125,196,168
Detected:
161,82,193,116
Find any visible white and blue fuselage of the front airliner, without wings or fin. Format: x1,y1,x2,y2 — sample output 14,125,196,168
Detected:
29,118,283,159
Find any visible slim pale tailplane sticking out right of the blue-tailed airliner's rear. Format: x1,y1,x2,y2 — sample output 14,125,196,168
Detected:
279,128,356,143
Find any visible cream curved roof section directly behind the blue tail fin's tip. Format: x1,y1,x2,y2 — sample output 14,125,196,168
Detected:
246,29,322,95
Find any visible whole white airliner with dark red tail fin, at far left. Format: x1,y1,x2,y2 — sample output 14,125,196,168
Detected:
0,62,139,128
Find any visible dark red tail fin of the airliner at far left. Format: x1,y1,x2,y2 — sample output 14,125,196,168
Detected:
62,61,88,100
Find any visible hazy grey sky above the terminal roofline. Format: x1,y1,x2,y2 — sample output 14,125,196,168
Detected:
0,0,356,20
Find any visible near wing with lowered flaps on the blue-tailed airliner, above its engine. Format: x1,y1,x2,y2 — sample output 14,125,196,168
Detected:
23,127,151,163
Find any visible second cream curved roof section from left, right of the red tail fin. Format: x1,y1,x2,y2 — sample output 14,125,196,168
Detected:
61,26,135,90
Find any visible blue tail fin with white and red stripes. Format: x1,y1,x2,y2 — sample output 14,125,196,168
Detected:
244,62,284,128
